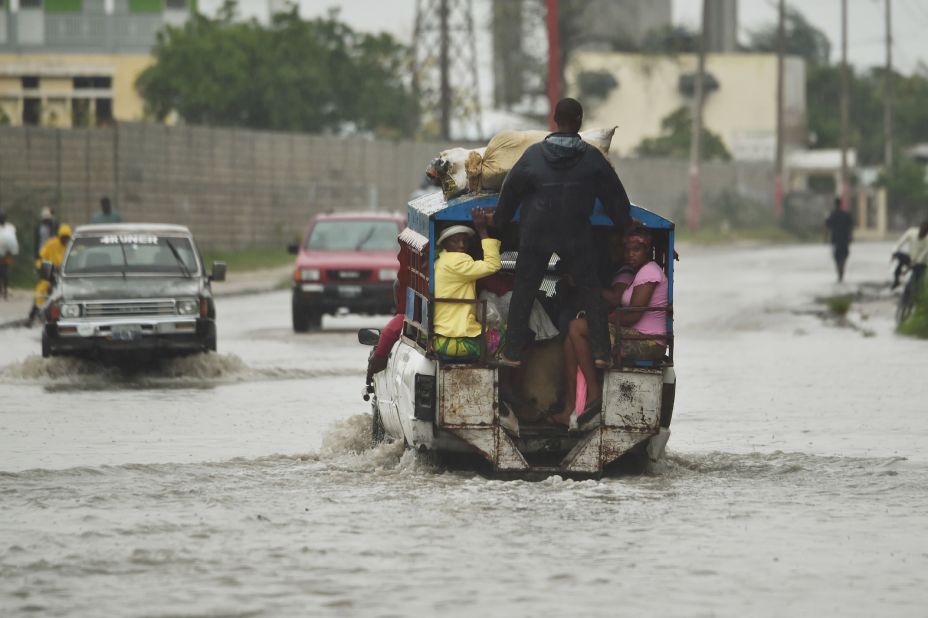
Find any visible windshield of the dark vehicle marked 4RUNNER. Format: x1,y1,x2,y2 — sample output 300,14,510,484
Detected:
63,233,198,275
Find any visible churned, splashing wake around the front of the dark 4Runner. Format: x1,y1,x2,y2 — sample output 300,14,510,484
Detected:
0,353,361,391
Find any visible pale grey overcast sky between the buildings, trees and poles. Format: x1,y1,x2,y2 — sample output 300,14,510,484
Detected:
200,0,928,73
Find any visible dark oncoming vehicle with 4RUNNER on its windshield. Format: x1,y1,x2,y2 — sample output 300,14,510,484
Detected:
42,224,226,357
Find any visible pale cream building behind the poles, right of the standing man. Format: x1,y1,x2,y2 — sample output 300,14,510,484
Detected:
566,52,806,160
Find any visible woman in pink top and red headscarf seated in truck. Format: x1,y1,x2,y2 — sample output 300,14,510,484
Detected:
610,228,667,360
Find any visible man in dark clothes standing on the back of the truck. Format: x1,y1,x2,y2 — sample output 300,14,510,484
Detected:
493,98,631,368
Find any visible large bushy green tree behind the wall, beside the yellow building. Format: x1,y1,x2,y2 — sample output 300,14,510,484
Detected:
136,1,418,136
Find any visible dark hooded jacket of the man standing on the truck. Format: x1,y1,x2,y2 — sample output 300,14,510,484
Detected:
493,133,631,246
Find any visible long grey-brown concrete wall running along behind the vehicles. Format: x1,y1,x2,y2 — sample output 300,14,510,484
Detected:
0,124,773,248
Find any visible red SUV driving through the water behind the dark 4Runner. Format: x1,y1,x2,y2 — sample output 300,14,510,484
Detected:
289,212,406,333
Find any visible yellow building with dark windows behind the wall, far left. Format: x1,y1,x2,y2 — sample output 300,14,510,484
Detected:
0,53,153,128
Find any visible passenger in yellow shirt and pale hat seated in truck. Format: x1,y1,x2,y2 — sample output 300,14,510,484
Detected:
432,208,501,359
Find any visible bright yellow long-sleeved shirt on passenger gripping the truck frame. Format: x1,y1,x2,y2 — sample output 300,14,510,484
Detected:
433,238,502,337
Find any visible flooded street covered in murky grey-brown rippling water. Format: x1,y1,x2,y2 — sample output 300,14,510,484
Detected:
0,243,928,617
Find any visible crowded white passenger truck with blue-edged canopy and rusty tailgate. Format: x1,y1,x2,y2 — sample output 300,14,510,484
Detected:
358,193,676,476
